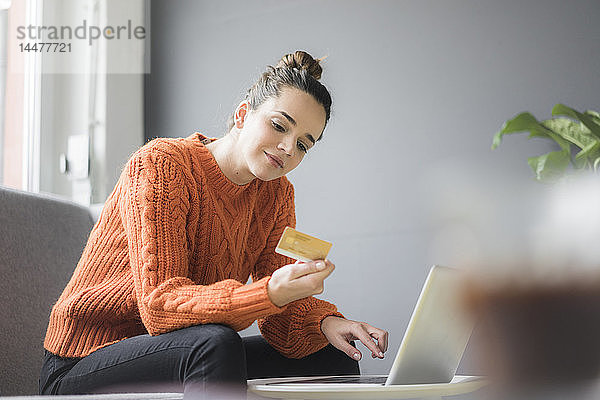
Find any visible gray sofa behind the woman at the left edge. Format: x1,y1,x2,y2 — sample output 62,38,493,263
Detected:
0,186,182,400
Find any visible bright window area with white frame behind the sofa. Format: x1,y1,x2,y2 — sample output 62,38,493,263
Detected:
0,0,149,205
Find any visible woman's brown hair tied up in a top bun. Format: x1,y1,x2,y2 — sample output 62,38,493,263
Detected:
228,50,331,140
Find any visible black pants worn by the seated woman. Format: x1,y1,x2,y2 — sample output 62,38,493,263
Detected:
40,324,360,399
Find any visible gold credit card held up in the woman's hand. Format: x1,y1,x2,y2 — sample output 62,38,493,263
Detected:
275,226,331,262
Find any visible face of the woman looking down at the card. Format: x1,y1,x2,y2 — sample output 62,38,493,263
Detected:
236,87,325,181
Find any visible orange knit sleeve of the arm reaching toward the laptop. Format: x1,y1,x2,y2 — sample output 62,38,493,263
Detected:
253,184,343,358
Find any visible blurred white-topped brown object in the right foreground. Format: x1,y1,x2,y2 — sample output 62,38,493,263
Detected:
465,176,600,399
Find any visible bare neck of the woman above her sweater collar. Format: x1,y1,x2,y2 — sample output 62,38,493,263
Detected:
205,132,255,186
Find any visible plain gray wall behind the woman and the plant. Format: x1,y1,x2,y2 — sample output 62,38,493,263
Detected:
146,0,600,373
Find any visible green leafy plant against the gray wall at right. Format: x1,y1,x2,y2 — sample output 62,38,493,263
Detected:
492,104,600,182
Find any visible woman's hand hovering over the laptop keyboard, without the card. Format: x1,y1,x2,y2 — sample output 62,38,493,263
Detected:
321,315,388,360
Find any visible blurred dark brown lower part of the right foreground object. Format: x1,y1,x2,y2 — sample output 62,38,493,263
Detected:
467,274,600,386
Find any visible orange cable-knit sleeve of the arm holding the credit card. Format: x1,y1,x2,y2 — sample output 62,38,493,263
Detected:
119,148,282,335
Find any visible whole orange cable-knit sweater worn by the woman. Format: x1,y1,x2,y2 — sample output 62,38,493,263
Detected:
44,133,341,358
